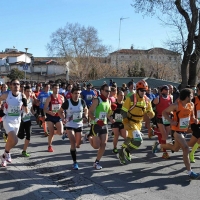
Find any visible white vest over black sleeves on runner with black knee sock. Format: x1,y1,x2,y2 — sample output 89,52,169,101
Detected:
65,98,83,128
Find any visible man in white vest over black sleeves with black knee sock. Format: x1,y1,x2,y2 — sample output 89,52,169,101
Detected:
58,87,88,170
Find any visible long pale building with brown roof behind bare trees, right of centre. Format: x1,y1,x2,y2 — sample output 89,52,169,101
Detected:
109,47,181,82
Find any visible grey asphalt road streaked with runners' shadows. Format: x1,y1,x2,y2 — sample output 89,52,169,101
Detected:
0,121,200,200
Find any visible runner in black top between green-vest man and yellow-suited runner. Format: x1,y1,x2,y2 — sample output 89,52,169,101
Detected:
108,91,127,154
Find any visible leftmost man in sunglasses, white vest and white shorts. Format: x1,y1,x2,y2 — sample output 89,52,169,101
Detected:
0,79,28,167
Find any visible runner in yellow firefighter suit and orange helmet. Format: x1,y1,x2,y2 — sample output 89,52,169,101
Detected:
118,80,154,164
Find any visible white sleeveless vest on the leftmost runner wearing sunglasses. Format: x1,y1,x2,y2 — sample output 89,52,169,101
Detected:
3,91,23,124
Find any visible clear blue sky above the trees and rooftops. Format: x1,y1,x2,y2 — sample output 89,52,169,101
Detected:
0,0,170,57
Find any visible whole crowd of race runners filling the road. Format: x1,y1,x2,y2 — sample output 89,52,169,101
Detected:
0,79,200,179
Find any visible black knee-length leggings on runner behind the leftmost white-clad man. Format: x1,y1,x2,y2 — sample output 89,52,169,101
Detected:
17,121,32,140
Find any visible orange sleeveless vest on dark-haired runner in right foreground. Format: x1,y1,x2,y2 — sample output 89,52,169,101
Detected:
171,101,193,132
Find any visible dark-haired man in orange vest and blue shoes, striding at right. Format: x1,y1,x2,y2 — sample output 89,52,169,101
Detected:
152,88,200,179
